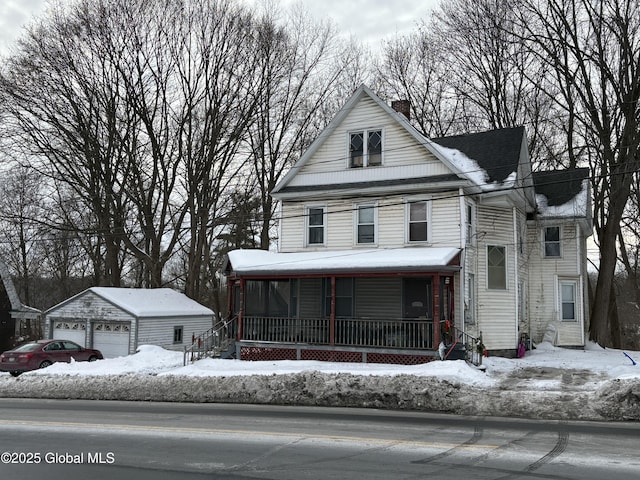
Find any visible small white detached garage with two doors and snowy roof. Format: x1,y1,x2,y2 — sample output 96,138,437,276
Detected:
45,287,213,358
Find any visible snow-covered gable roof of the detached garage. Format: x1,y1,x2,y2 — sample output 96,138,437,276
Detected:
46,287,213,318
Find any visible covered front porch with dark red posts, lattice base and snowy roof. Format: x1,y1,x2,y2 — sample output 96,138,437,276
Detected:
226,248,459,364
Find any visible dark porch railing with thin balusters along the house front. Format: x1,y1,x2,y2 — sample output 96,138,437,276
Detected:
242,317,434,349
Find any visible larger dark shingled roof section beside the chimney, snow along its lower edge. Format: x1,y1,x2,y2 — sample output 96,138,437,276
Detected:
431,127,525,183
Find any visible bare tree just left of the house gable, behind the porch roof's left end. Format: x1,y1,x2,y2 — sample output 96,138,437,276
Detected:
248,4,363,249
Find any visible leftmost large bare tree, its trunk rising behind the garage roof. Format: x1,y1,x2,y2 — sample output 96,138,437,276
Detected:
0,0,133,285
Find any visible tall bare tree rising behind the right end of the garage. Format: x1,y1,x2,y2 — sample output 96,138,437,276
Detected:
172,0,261,299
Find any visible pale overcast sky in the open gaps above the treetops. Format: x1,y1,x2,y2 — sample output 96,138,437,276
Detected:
0,0,439,53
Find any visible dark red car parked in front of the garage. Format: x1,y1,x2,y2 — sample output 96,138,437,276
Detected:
0,340,103,377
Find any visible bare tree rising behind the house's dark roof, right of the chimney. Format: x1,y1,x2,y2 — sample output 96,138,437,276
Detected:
376,0,557,162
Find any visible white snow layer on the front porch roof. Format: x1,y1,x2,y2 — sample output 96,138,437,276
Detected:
229,247,460,275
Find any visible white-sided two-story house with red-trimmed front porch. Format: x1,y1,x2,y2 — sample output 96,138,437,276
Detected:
226,86,591,363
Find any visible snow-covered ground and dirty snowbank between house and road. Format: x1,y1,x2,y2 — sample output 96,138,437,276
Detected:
0,343,640,420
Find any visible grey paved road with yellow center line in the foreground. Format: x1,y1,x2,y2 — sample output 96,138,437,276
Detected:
0,399,640,480
